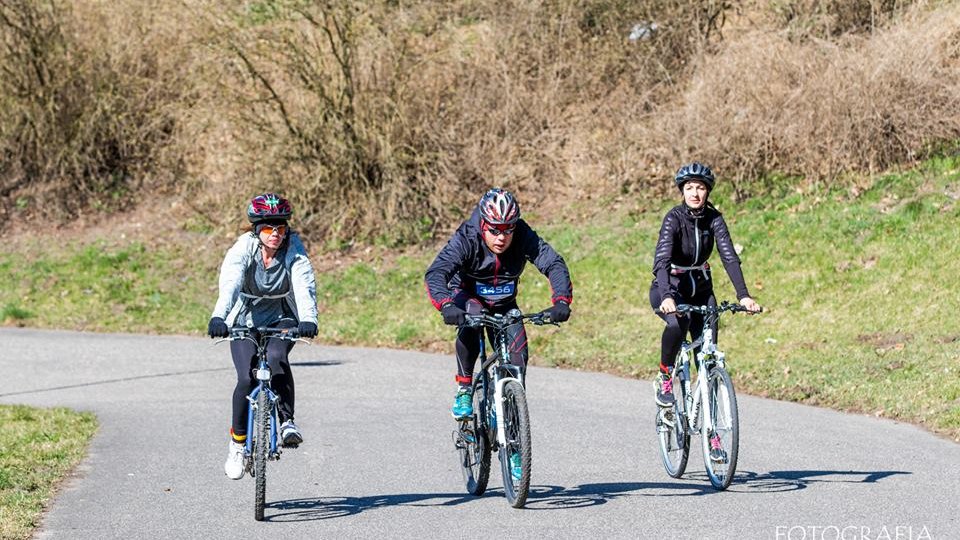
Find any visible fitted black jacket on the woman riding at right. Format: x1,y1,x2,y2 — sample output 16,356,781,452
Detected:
651,204,750,301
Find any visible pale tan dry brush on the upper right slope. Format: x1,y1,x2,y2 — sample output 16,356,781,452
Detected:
638,1,960,196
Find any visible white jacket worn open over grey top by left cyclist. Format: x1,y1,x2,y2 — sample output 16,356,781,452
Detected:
211,232,317,326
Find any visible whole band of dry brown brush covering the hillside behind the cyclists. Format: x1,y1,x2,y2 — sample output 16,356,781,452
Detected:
0,0,960,248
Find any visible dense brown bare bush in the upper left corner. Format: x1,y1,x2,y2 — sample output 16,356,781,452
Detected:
0,0,195,220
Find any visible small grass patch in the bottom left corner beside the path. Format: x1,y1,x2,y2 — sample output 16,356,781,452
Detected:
0,405,97,539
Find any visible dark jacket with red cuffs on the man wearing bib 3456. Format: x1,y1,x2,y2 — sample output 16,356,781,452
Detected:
424,209,573,309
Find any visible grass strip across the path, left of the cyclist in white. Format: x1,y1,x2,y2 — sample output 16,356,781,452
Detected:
0,238,214,333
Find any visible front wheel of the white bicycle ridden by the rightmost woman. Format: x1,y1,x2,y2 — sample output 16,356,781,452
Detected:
700,367,740,490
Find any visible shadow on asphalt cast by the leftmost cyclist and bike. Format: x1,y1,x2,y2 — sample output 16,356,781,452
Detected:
264,491,490,522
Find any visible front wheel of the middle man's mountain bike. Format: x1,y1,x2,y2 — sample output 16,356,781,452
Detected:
497,381,533,508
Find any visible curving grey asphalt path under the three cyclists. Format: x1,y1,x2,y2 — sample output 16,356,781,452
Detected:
0,328,960,540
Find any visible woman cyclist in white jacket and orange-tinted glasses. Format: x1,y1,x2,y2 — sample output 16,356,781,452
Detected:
207,193,317,480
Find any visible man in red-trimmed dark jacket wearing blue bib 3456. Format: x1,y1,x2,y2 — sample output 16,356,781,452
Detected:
425,188,573,419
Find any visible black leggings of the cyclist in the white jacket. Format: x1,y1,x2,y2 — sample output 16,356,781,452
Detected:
230,325,295,436
